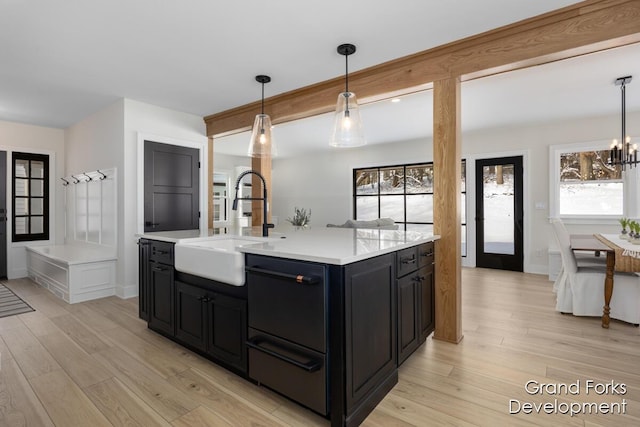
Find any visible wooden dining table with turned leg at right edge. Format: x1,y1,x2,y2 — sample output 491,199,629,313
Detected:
570,234,640,328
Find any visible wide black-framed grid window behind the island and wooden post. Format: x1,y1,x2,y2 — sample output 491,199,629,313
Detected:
353,160,466,256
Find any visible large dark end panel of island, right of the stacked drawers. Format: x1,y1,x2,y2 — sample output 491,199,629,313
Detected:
344,254,397,412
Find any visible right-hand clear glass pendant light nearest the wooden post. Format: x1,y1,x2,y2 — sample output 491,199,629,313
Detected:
329,44,366,147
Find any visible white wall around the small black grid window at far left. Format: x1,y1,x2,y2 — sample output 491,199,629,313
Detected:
0,121,65,279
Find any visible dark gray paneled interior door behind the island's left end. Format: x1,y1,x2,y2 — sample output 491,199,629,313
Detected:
144,141,200,232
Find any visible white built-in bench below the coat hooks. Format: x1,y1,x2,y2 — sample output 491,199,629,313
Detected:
27,244,117,304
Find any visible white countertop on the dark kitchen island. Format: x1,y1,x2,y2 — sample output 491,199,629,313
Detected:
140,226,440,265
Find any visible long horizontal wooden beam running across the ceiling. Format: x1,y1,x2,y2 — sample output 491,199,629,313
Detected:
205,0,640,136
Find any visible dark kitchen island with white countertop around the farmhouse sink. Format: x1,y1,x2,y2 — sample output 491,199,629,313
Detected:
140,228,437,426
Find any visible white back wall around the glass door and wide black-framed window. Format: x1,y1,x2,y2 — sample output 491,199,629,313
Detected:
273,112,640,274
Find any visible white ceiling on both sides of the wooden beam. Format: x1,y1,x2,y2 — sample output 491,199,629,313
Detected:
0,0,640,159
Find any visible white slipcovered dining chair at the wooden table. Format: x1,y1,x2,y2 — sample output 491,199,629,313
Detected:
551,221,640,325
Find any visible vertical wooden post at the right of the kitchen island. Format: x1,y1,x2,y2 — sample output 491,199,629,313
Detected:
433,77,462,343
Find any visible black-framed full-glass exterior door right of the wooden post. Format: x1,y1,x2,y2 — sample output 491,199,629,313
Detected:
475,156,524,271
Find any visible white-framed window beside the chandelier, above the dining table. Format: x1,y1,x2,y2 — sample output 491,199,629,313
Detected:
551,143,625,218
